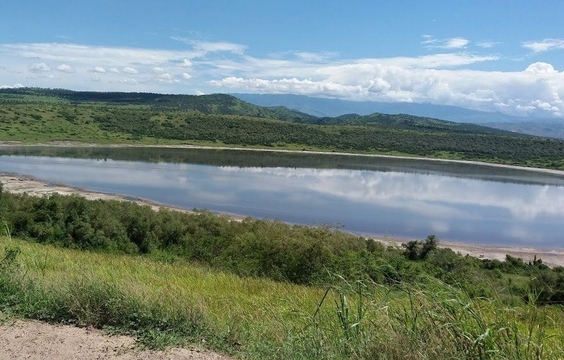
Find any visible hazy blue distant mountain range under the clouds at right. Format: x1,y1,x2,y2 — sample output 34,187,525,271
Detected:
232,94,564,138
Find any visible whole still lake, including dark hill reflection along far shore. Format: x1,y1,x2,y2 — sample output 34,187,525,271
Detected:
0,147,564,247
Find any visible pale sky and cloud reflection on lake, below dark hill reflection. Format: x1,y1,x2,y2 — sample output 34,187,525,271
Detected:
0,156,564,247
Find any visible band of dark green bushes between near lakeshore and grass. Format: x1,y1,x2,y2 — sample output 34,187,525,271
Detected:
0,188,564,303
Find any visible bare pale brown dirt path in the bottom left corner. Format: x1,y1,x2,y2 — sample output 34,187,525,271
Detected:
0,320,234,360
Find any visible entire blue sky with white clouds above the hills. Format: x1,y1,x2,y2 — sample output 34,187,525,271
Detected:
0,0,564,121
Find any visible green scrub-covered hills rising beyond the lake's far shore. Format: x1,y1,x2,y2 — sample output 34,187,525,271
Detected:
0,89,564,169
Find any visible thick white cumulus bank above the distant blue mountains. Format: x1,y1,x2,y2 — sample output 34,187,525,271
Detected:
210,61,564,116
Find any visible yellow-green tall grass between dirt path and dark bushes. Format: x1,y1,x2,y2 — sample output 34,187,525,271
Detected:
0,238,564,359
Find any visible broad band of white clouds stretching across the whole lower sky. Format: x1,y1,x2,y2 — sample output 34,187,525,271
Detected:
0,41,564,116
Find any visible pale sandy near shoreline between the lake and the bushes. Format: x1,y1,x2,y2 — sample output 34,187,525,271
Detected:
0,173,564,266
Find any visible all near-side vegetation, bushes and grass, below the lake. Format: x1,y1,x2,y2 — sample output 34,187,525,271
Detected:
0,187,564,359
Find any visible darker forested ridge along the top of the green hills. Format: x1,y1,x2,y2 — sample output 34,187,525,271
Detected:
0,88,514,135
